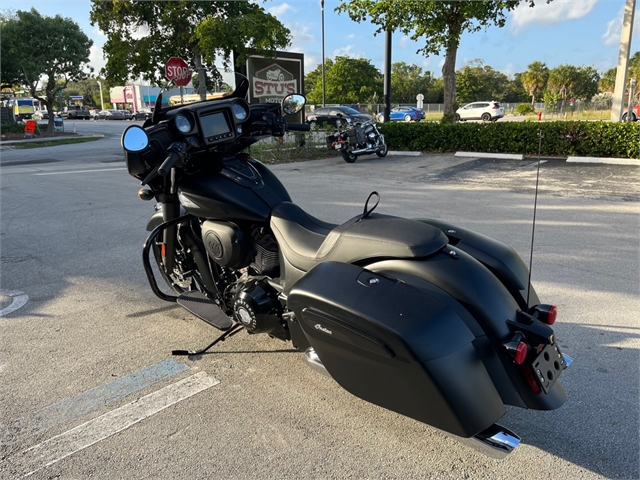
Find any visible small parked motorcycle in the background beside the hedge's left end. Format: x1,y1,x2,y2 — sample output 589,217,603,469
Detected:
326,118,389,163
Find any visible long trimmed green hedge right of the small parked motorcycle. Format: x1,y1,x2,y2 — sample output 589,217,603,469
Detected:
380,121,640,158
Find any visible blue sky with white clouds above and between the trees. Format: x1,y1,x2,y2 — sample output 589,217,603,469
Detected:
0,0,640,81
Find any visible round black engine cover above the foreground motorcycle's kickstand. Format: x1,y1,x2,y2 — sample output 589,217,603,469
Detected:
233,280,289,340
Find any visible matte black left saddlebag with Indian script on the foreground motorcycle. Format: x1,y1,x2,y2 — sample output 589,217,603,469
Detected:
288,262,505,437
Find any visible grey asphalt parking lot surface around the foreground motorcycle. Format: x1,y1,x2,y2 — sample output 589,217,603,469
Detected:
0,137,640,479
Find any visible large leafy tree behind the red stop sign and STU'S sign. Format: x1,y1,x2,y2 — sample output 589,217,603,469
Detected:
90,0,291,98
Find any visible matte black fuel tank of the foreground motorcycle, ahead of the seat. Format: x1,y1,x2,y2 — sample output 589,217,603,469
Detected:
178,157,291,223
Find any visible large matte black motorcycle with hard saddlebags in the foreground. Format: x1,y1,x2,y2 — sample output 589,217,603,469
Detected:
122,74,571,456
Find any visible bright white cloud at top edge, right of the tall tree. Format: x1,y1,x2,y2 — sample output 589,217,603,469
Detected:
509,0,598,33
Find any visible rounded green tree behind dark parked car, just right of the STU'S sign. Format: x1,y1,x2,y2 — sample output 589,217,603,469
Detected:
304,56,383,104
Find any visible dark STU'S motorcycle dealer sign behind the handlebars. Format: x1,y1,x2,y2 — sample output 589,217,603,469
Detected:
246,52,304,122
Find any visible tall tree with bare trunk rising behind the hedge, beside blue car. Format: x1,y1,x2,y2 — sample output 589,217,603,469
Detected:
336,0,551,121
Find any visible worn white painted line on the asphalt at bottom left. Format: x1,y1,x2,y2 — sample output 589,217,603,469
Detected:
8,372,220,477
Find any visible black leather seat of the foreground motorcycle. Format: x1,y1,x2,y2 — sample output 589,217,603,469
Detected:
271,202,448,272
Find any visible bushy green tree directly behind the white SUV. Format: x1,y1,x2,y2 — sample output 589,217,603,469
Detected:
456,59,509,104
